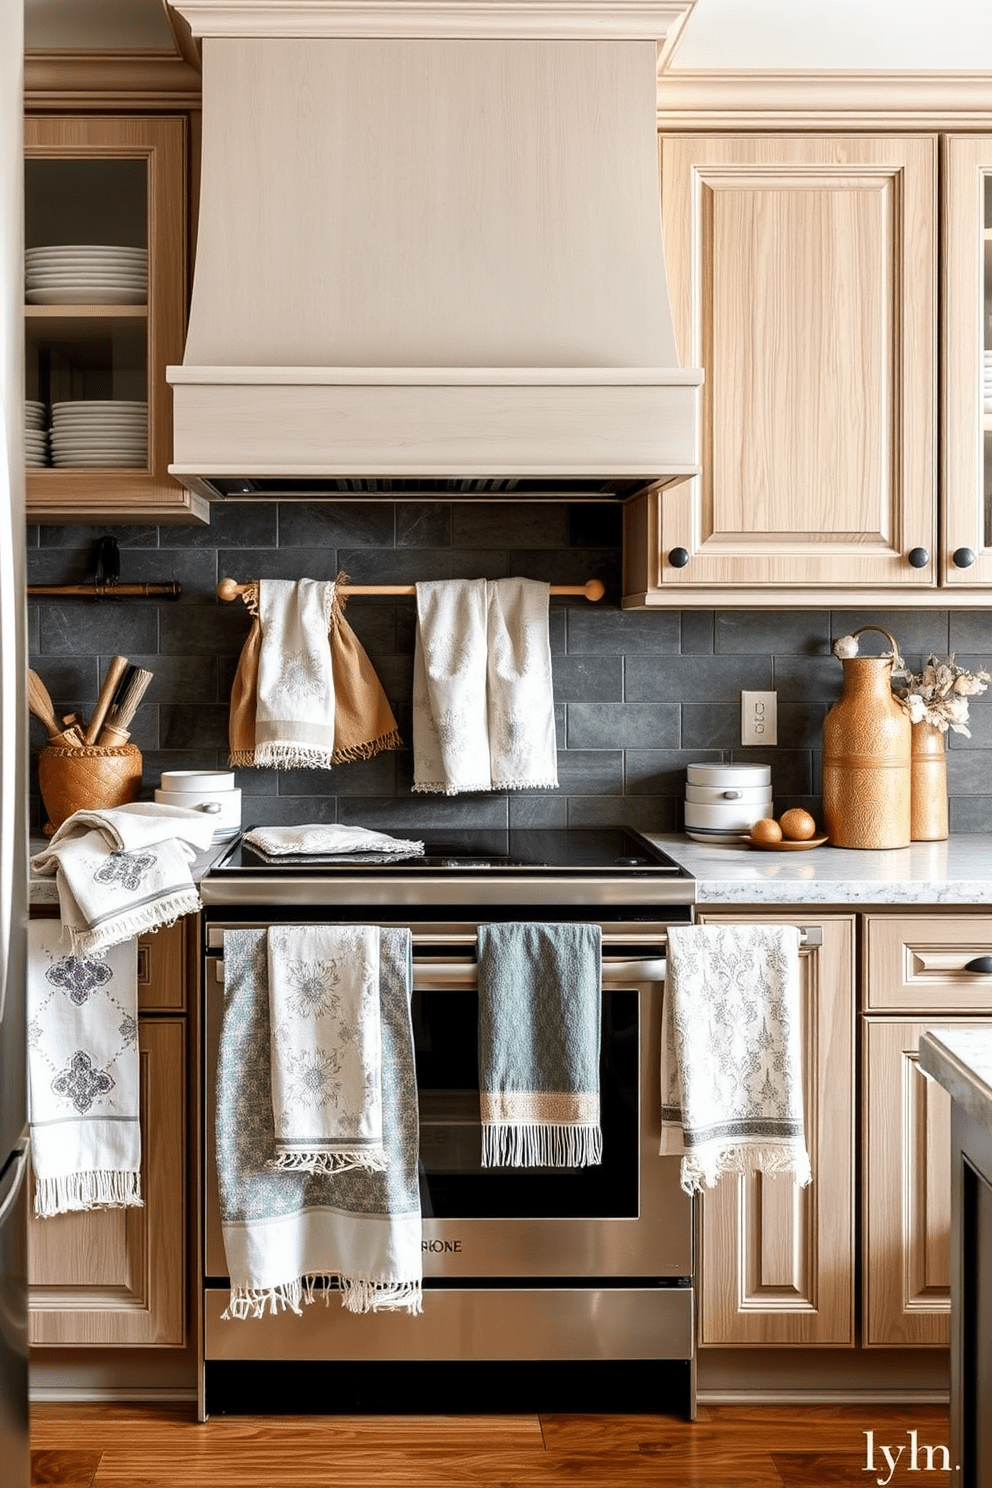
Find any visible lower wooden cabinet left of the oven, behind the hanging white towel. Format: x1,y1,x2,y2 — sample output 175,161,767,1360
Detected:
28,921,189,1348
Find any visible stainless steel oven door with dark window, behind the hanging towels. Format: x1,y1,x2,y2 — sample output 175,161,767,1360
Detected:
204,921,693,1284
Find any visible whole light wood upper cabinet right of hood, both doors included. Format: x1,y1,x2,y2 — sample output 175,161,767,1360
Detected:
625,134,992,609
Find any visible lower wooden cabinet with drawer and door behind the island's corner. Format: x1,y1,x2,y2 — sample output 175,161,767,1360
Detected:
861,914,992,1347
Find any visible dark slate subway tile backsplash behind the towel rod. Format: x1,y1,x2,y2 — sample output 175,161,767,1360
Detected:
27,501,992,832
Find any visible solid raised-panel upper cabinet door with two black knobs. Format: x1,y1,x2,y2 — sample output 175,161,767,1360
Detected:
628,135,937,592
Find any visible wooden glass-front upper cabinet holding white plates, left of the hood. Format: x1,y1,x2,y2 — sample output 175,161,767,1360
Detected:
24,115,205,521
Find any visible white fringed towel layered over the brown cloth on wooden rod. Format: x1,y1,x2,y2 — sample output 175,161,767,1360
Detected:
254,579,335,769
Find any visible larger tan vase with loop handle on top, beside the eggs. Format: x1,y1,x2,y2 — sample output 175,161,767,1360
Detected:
822,625,912,848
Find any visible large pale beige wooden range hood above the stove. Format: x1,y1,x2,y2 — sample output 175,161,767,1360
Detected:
168,0,702,500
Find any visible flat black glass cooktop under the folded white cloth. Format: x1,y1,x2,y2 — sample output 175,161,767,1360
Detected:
211,827,690,878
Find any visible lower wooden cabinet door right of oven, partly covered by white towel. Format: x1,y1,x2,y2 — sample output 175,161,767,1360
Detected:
698,911,855,1347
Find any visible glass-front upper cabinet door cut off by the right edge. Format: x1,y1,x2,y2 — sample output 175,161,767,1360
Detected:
941,135,992,588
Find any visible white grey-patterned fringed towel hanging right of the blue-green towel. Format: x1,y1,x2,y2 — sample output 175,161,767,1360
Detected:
660,926,811,1193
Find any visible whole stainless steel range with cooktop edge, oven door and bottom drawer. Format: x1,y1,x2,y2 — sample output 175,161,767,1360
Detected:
201,832,695,1415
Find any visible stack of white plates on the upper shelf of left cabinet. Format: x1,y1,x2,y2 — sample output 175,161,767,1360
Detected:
24,243,149,305
